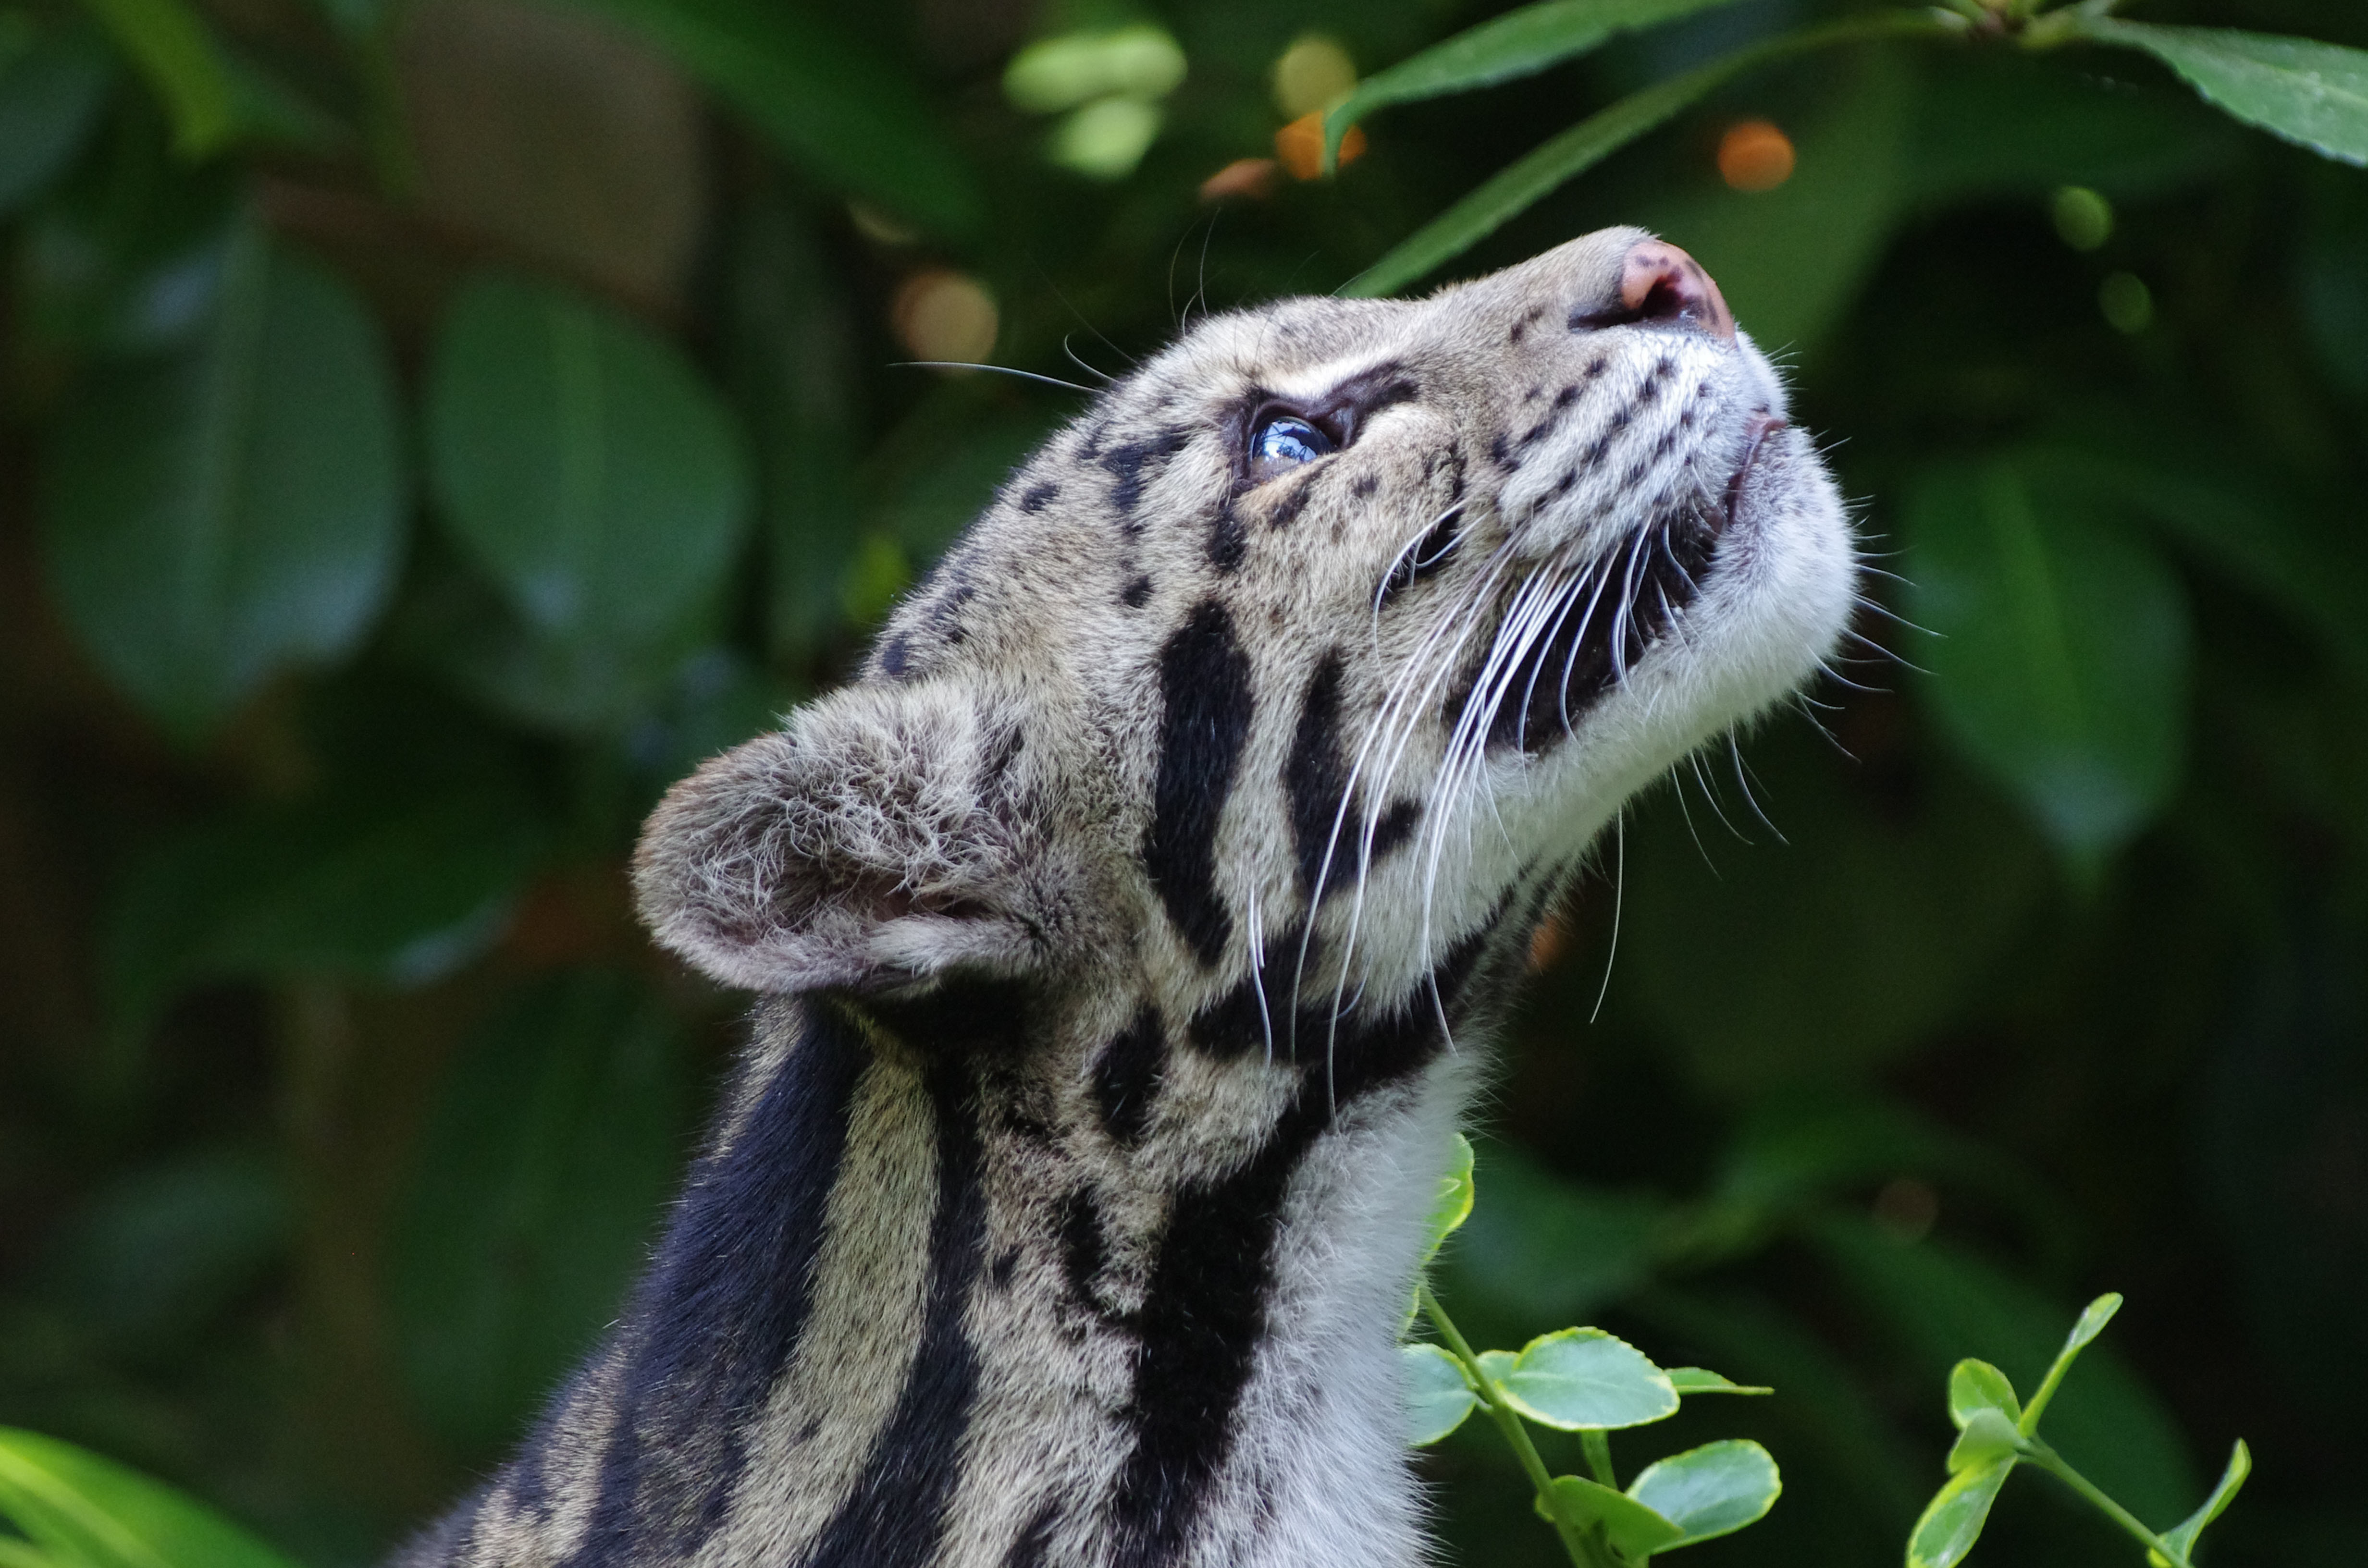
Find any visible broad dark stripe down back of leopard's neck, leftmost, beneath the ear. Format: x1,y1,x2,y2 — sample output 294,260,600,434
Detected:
568,1004,867,1568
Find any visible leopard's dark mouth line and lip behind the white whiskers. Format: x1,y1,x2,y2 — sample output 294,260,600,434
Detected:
1449,412,1786,756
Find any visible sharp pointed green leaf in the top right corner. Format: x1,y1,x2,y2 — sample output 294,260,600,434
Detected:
2067,14,2368,166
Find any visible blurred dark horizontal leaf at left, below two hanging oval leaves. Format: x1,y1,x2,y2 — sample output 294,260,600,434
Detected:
104,782,544,1033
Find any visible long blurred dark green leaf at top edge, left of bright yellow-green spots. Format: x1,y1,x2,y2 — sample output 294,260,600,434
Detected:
563,0,985,237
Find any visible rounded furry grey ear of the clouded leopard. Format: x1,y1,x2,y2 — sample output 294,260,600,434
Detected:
632,682,1059,992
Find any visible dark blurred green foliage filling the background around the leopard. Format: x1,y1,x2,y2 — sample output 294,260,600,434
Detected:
0,0,2368,1568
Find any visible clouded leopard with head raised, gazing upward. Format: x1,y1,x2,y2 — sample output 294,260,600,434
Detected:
407,230,1854,1568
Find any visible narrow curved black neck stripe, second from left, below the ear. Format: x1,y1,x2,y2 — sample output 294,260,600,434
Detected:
795,1052,987,1568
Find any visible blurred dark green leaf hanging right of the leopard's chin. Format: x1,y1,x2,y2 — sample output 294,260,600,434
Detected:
1906,462,2190,874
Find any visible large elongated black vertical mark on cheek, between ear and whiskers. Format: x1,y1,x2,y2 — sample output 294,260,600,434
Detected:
1144,599,1253,964
